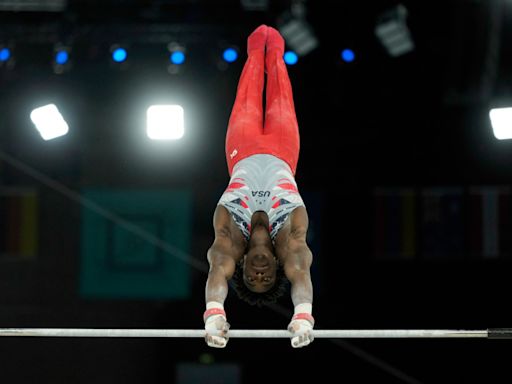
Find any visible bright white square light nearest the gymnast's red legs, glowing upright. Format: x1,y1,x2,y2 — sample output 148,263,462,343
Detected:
146,105,185,140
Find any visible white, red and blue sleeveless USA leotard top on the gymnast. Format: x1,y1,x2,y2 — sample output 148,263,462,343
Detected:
218,155,304,240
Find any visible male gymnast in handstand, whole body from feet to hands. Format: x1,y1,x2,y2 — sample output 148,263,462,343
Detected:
203,25,314,348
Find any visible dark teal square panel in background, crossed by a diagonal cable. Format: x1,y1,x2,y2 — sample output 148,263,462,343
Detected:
80,189,192,300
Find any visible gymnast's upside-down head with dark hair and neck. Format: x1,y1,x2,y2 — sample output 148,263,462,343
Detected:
232,219,287,306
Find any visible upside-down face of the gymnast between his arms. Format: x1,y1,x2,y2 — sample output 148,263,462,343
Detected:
243,245,277,293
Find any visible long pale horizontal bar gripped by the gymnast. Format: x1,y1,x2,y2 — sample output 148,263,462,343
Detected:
0,328,494,339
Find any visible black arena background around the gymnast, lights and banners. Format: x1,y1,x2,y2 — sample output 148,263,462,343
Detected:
0,0,512,384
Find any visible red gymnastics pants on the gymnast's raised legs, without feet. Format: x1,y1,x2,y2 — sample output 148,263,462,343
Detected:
226,39,300,175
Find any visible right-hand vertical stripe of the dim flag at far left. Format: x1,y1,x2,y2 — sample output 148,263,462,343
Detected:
19,193,39,258
